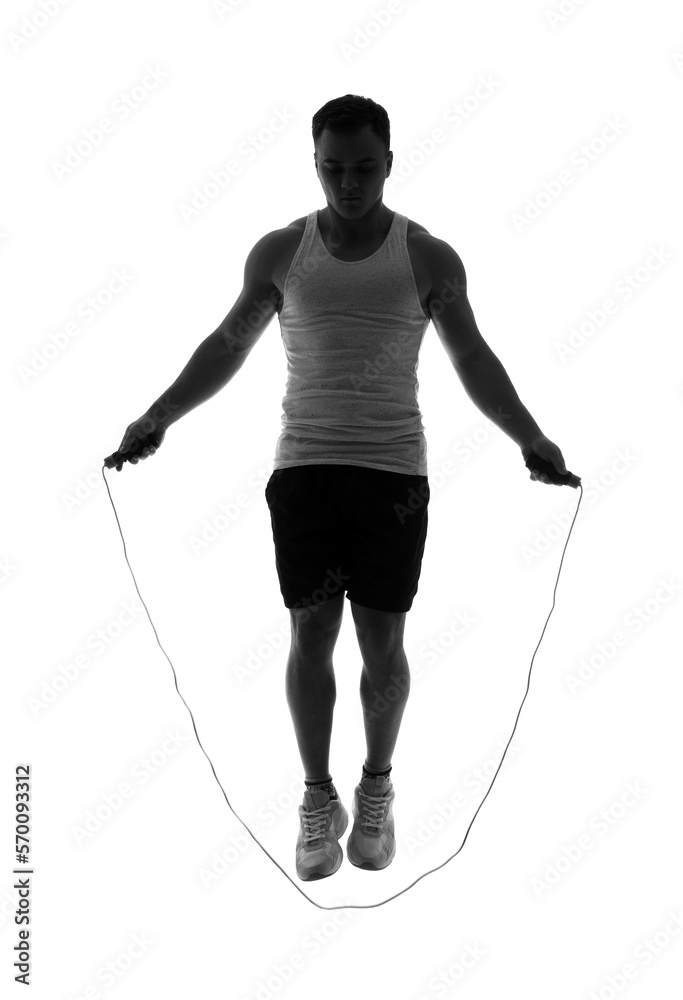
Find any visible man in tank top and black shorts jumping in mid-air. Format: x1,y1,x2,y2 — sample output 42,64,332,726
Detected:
111,94,566,880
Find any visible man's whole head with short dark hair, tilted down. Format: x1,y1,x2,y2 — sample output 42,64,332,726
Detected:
312,94,394,217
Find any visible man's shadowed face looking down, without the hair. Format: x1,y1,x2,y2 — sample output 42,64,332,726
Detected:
315,125,394,218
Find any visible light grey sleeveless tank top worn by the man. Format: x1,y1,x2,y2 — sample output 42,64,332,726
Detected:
274,210,430,476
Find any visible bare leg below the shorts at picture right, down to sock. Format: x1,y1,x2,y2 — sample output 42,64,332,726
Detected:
351,601,410,771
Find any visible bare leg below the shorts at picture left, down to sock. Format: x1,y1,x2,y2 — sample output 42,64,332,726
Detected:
286,593,344,779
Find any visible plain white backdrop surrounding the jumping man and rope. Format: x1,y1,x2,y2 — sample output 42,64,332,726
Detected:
0,0,683,1000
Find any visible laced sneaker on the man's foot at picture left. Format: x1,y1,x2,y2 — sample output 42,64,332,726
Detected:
296,789,349,882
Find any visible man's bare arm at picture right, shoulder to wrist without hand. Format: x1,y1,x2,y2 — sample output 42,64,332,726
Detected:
428,240,545,448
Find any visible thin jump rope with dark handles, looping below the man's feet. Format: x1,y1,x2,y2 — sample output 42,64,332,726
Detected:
102,444,583,910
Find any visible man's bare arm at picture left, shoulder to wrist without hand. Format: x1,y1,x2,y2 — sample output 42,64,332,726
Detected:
146,230,279,427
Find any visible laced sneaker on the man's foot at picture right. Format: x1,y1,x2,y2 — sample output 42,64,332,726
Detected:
346,777,396,871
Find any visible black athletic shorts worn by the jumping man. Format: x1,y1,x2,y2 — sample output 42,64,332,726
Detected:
265,465,429,612
